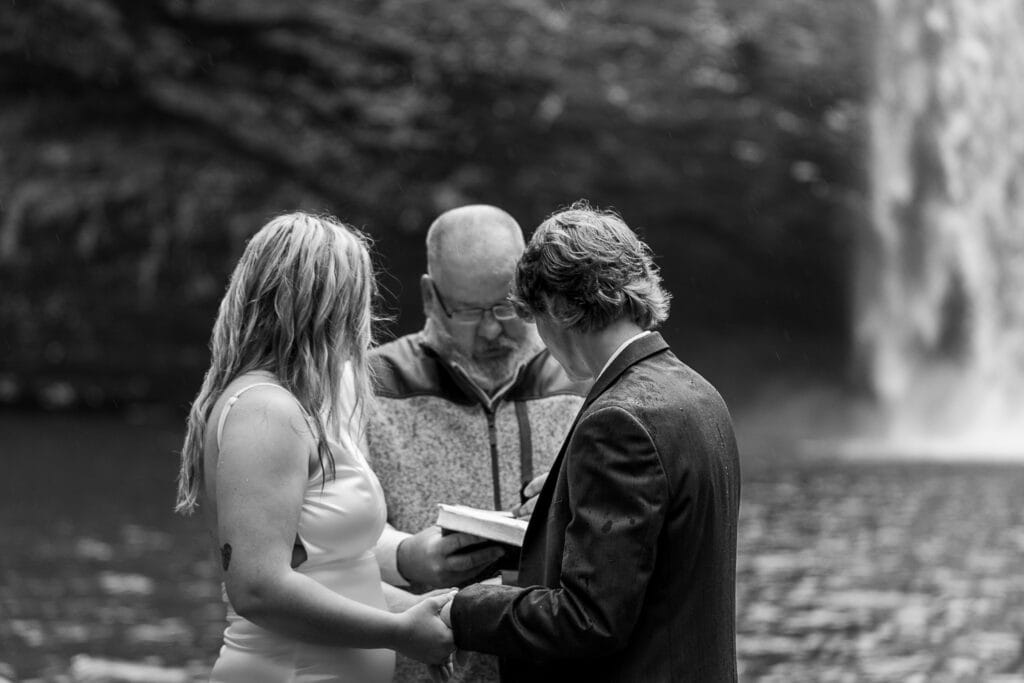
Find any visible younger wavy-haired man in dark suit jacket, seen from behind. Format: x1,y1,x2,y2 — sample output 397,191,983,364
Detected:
442,203,739,683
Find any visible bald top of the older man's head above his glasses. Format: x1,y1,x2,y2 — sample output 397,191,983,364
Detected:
427,204,525,283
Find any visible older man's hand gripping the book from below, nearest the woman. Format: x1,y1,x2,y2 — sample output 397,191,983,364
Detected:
398,526,505,588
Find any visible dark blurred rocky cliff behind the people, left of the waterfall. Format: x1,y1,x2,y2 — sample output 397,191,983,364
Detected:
0,0,871,404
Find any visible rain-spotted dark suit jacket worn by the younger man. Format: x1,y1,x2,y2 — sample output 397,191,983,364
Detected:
452,334,739,683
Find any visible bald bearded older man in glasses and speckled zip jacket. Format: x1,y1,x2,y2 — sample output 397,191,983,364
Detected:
367,205,587,683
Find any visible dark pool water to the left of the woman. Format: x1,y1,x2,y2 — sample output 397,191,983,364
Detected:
0,414,223,680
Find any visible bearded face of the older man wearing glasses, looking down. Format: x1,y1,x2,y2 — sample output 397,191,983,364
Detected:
428,272,537,386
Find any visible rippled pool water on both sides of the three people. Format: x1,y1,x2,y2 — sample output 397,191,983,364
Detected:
0,414,1024,683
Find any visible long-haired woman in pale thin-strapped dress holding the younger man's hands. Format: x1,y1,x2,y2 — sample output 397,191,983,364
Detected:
177,213,454,683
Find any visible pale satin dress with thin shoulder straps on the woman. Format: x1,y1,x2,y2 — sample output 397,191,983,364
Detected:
210,382,394,683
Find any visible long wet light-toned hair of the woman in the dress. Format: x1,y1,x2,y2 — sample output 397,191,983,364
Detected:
175,213,376,515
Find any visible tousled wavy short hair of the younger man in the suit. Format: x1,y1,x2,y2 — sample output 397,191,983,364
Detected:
509,200,672,332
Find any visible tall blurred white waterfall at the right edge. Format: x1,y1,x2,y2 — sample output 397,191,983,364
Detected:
853,0,1024,456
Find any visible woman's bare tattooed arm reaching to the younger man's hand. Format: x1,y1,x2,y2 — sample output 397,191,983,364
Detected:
210,392,453,663
